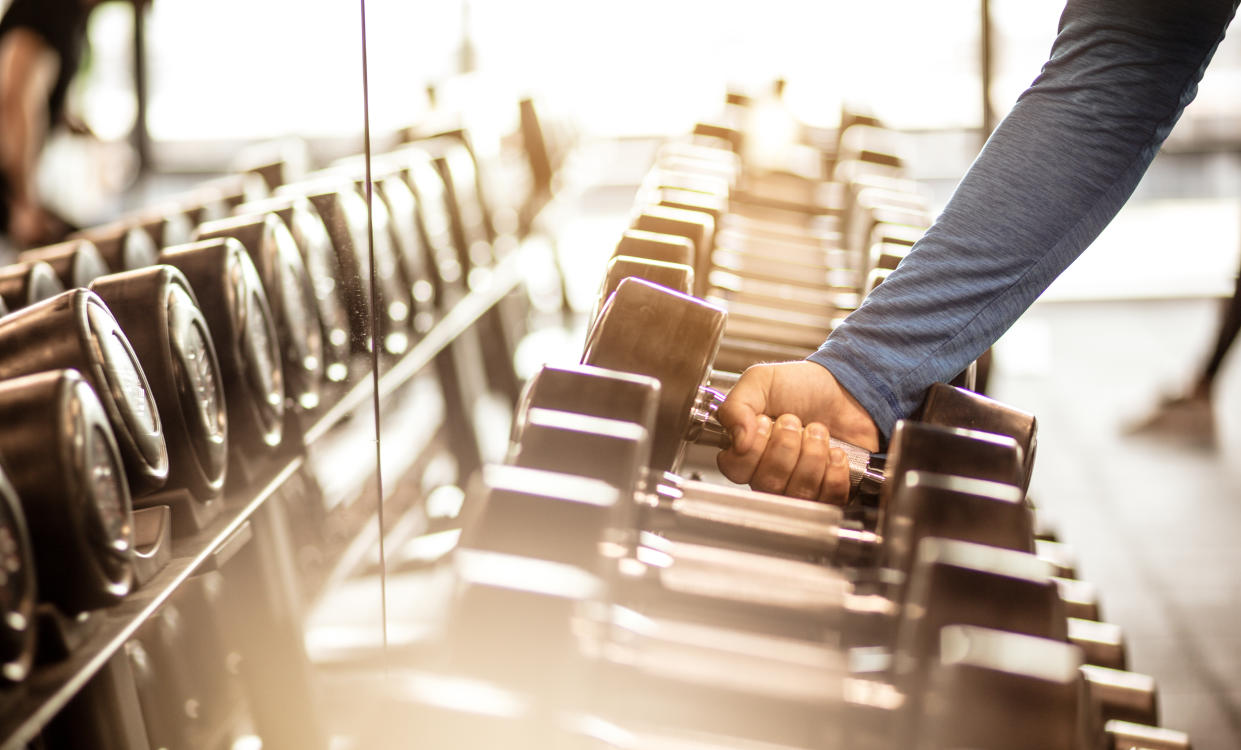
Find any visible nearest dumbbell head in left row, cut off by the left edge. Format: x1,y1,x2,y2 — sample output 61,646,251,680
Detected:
0,471,37,682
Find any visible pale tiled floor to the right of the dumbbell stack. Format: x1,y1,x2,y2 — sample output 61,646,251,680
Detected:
993,299,1241,750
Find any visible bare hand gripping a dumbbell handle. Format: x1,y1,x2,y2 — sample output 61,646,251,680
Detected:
716,361,879,503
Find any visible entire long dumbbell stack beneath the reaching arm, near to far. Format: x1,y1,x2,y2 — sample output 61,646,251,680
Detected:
392,97,1189,750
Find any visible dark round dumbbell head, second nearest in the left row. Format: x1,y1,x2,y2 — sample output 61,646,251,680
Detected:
0,370,133,615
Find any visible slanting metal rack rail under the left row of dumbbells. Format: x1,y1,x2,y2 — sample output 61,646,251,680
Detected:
0,229,533,750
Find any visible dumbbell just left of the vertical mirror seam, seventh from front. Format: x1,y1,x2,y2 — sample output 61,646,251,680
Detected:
237,195,351,382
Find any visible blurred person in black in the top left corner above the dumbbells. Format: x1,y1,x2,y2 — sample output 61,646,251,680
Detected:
0,0,99,247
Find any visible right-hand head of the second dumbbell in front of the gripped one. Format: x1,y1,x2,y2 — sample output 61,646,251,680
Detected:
884,471,1034,574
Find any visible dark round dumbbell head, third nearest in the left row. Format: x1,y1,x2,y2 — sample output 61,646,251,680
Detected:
0,289,169,492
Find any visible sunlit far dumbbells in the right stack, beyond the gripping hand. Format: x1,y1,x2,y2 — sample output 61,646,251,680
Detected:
590,113,928,370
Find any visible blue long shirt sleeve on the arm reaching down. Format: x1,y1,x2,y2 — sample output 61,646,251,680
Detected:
808,0,1237,436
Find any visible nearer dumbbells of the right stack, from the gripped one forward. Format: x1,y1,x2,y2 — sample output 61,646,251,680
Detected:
382,108,1188,749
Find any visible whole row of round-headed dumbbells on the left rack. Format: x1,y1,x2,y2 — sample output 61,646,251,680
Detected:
0,124,526,715
